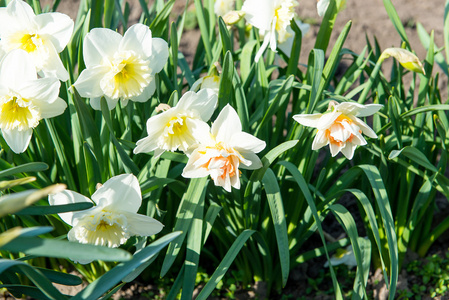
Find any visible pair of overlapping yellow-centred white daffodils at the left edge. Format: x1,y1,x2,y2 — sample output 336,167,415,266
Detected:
0,0,73,153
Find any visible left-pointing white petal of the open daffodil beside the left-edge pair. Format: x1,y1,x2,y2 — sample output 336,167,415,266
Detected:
73,66,108,98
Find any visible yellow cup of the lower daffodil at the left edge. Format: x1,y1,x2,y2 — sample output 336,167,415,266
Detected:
0,95,41,131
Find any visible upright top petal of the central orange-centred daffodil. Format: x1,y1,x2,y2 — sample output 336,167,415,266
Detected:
211,104,242,144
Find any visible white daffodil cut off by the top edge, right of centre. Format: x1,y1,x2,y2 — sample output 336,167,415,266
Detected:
242,0,298,62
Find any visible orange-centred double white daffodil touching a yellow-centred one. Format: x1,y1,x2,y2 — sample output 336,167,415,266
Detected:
182,104,266,192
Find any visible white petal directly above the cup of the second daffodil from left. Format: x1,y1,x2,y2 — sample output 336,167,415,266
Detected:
119,24,152,59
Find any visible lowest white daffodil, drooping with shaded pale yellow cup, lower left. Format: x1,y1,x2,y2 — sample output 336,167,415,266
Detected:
48,174,164,263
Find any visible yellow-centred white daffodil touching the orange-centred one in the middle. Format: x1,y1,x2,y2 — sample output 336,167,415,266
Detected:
134,89,218,157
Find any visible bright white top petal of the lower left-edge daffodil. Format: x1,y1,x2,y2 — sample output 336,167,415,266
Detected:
0,49,37,90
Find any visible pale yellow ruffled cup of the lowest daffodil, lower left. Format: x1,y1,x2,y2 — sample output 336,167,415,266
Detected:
72,210,130,247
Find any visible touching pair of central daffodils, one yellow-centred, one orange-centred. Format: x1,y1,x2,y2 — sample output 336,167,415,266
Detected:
134,88,265,192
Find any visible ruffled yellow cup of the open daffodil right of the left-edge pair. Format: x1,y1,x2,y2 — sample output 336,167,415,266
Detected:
100,51,152,99
